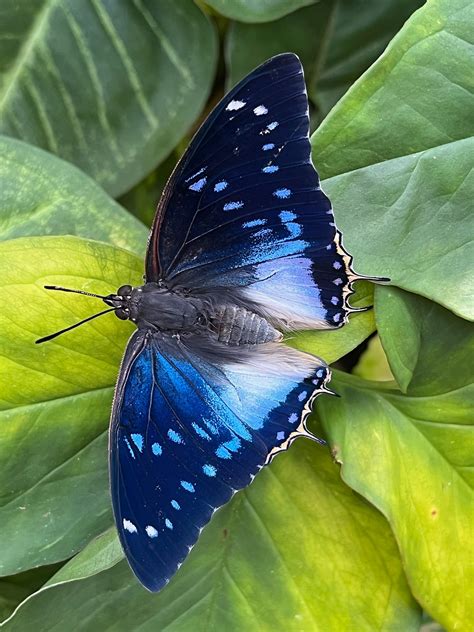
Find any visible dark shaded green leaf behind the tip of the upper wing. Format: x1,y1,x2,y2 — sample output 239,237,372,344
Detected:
226,0,422,119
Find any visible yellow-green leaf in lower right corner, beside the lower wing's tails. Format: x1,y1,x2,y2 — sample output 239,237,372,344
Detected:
318,368,474,630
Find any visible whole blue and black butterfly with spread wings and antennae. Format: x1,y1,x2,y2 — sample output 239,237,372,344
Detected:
36,53,383,591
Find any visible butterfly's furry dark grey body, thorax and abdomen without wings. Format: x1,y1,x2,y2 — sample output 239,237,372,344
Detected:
119,283,282,346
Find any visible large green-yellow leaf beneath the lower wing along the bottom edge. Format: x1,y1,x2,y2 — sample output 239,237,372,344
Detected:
5,441,420,632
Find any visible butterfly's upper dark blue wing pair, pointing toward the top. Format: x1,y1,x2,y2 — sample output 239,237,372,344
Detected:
146,54,362,328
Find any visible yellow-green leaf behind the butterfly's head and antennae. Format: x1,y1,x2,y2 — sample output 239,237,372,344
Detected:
0,237,143,575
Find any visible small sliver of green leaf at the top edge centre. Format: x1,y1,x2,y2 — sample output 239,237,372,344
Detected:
206,0,315,22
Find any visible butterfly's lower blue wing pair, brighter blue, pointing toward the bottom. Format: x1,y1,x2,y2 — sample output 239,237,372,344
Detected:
110,331,329,591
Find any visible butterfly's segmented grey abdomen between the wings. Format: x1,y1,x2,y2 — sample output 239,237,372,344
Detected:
210,305,282,346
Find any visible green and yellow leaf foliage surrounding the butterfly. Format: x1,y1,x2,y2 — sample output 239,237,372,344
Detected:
0,0,474,632
